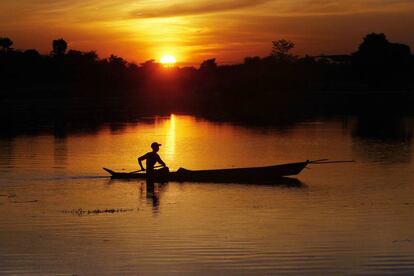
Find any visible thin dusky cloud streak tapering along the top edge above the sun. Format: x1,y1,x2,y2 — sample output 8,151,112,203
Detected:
131,0,270,18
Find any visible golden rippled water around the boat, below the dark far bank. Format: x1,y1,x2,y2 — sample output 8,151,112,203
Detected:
0,115,414,275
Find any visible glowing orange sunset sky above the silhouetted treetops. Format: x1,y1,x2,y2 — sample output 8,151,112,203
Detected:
0,0,414,65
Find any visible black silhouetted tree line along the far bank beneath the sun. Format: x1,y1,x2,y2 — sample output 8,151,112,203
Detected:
0,33,414,117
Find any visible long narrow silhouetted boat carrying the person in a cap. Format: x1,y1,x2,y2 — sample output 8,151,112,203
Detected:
103,161,309,183
